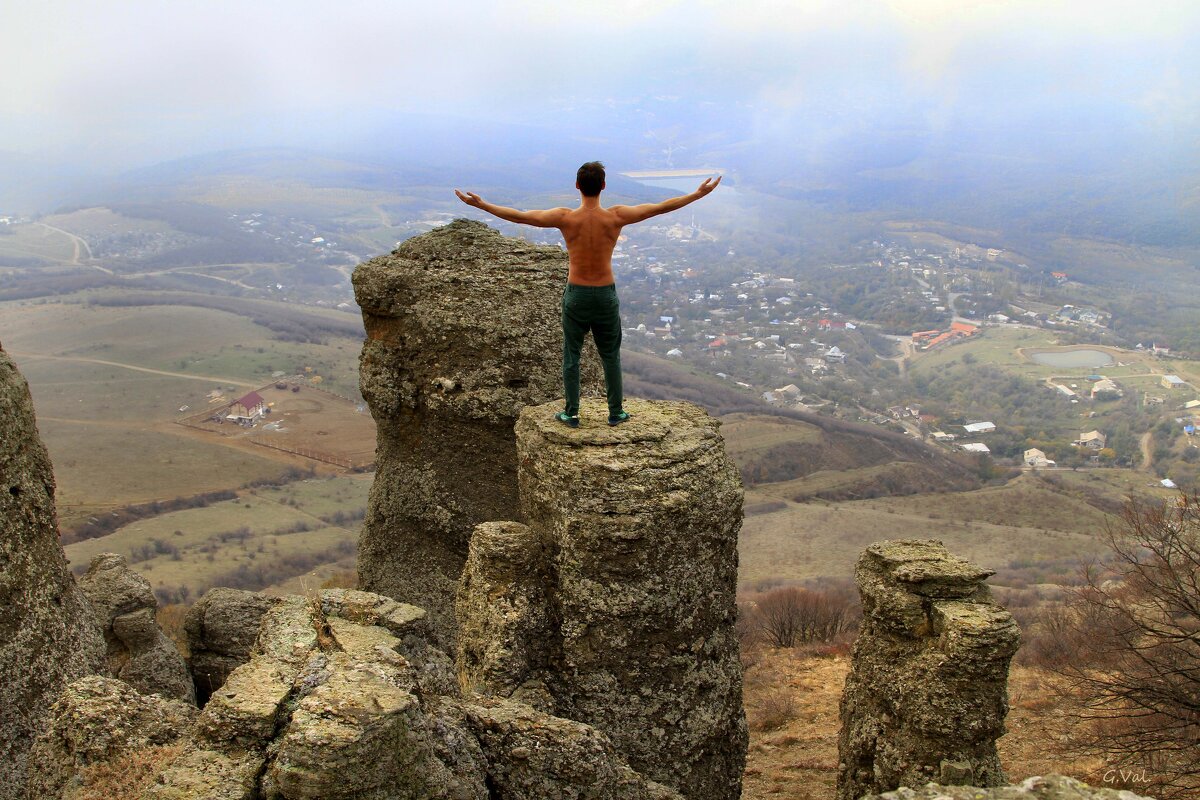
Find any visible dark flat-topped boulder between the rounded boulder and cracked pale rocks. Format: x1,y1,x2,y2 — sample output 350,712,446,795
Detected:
184,587,278,705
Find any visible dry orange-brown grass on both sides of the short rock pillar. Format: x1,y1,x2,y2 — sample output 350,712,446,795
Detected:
742,649,1105,800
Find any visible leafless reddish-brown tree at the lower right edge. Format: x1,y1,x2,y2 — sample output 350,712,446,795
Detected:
1054,495,1200,798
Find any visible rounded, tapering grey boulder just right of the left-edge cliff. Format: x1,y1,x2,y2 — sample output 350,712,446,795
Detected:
79,553,196,705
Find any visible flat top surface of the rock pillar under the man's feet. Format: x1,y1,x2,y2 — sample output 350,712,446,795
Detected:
517,398,720,447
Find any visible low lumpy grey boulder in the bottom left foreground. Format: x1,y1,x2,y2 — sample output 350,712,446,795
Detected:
29,675,197,800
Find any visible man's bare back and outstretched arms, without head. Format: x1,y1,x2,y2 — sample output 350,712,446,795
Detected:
455,178,721,287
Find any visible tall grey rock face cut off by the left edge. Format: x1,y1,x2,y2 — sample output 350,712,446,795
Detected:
0,349,104,800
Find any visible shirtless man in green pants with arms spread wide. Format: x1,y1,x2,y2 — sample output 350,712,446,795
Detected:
455,161,721,428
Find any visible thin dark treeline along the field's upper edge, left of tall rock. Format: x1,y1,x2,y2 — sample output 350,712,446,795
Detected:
91,293,365,344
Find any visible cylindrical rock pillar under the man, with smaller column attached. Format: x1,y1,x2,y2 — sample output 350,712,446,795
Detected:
458,401,746,800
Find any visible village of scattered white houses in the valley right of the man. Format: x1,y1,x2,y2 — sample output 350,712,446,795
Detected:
604,225,1200,486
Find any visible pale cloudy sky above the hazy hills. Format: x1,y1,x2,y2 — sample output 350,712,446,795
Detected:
0,0,1200,166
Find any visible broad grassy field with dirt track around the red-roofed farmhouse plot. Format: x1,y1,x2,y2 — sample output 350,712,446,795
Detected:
0,297,374,528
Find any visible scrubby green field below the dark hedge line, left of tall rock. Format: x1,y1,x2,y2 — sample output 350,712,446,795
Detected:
65,475,364,602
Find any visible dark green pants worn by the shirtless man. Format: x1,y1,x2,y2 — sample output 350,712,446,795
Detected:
563,283,624,416
